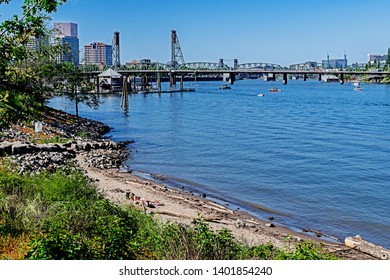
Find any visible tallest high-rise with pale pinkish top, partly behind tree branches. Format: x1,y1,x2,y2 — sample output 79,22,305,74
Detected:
54,22,80,65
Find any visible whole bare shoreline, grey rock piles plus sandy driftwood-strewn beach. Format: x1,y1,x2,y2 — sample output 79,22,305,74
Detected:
0,106,390,260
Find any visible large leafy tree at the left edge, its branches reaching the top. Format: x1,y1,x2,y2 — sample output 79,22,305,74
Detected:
0,0,66,128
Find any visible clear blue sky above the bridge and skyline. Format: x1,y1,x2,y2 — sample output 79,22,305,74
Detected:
0,0,390,66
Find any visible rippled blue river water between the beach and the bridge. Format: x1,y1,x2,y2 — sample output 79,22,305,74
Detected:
49,80,390,248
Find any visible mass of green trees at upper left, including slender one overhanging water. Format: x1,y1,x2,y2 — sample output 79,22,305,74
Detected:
0,0,99,129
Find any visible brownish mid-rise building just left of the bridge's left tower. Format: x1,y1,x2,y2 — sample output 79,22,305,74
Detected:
84,42,112,65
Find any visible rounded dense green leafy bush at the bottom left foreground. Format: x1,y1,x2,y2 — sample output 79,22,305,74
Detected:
26,200,136,260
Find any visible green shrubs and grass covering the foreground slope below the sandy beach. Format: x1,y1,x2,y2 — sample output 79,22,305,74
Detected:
0,159,334,260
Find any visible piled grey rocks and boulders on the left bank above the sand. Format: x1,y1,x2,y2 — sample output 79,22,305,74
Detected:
0,109,129,173
